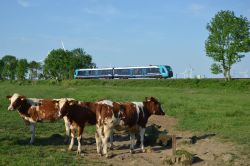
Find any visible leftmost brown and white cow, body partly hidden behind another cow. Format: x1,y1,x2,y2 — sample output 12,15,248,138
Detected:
6,93,70,144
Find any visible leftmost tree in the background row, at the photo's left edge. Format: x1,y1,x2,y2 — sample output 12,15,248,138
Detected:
2,55,17,80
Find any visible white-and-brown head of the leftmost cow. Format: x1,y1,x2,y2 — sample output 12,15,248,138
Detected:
6,93,25,111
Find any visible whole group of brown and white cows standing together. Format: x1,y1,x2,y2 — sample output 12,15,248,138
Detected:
6,93,165,157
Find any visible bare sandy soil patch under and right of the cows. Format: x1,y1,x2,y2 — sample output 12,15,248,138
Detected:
75,116,250,166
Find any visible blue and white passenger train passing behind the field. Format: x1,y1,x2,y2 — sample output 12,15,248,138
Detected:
74,65,173,79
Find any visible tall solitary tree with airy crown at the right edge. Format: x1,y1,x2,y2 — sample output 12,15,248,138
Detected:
205,11,250,80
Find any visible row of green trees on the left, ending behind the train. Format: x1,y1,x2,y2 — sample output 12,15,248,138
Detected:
0,48,96,80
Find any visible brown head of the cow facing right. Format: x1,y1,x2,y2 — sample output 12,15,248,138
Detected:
143,97,165,115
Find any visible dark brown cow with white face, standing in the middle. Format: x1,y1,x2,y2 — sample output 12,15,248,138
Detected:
59,99,97,154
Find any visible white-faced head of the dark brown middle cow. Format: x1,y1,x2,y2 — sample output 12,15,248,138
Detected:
57,98,76,117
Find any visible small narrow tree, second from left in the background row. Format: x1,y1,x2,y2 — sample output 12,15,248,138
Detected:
16,59,28,80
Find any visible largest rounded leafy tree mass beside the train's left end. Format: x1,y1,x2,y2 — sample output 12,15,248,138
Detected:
44,48,94,80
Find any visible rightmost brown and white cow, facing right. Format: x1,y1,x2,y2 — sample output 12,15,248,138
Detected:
97,97,165,156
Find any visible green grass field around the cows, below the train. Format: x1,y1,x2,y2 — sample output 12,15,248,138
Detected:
0,80,250,165
